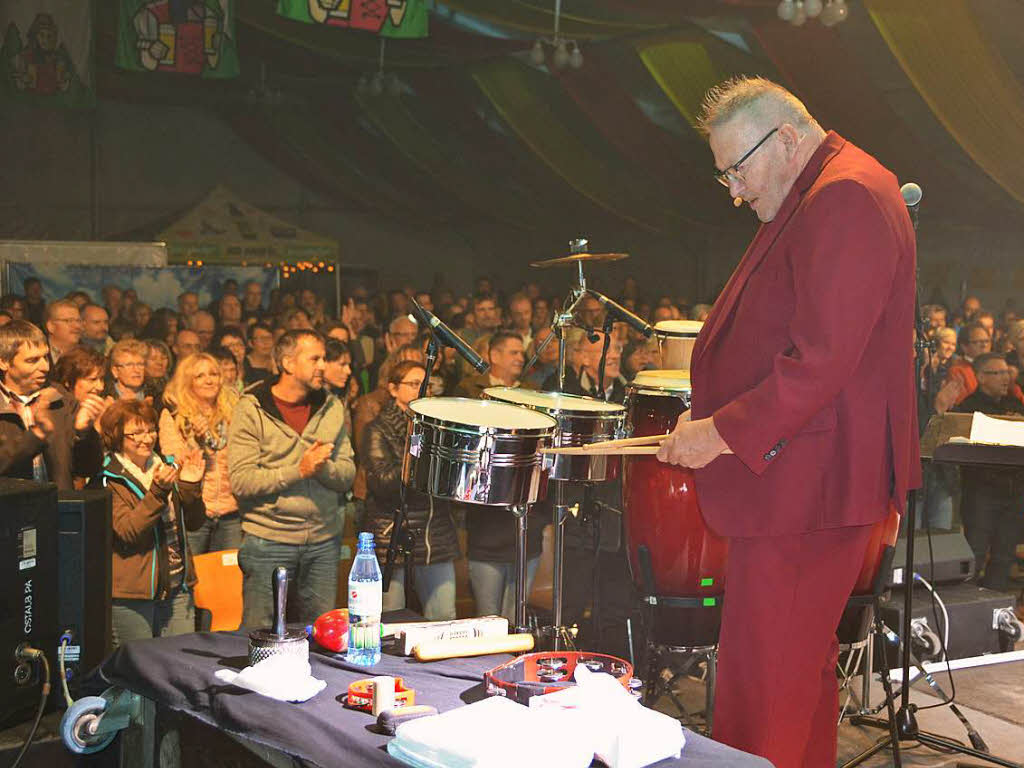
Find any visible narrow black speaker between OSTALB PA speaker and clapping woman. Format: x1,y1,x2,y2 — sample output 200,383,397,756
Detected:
53,488,112,700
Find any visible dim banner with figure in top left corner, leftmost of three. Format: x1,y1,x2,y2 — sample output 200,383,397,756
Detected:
0,0,96,106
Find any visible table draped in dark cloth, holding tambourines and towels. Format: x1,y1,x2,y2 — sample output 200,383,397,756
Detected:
89,616,771,768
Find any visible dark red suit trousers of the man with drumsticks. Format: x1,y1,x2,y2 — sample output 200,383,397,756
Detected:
713,525,872,768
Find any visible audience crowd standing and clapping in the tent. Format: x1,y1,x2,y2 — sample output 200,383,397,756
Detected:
0,279,1024,653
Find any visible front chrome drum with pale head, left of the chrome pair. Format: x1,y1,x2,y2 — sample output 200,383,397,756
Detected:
402,397,557,507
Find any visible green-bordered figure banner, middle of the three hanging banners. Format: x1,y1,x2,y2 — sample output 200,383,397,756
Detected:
117,0,239,78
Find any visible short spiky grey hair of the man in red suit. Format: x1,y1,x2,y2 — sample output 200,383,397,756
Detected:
697,75,817,136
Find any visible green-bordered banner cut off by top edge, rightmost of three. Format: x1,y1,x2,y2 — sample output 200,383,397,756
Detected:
278,0,429,38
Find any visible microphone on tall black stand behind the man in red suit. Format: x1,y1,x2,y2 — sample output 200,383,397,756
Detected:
843,192,1022,768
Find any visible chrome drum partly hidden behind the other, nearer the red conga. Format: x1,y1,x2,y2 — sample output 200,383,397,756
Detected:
483,387,626,482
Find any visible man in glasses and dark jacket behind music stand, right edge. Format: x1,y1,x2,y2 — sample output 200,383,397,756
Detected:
954,352,1024,590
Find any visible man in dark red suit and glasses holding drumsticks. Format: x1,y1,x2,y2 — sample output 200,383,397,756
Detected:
658,78,920,768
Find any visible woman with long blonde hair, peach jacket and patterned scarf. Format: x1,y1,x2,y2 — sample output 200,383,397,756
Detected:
160,352,242,555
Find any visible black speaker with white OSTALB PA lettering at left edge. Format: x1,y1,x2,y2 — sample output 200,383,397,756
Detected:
0,478,58,728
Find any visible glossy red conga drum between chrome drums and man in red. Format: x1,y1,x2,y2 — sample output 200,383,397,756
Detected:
623,370,728,647
